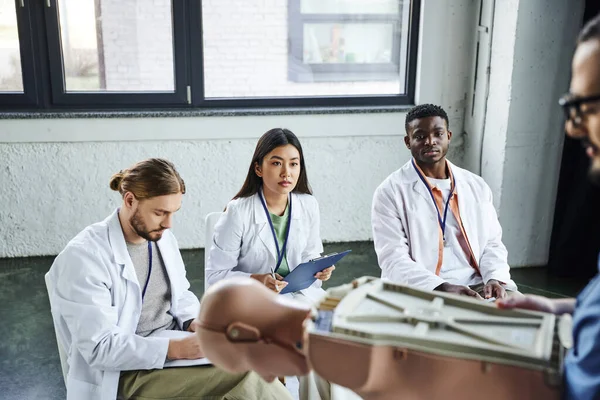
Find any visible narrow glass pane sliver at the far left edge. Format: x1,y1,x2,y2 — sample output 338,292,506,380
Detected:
0,0,23,92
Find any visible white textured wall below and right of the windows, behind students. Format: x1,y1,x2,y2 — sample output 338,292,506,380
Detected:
0,0,474,257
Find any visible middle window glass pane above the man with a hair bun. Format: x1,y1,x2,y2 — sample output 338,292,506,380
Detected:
59,0,175,92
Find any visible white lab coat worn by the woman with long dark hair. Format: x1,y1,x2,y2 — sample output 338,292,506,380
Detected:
205,193,325,301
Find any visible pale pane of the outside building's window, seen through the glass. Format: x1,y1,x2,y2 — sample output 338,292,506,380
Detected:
303,23,394,64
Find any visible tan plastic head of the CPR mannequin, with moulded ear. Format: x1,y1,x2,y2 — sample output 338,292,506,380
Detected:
197,278,310,381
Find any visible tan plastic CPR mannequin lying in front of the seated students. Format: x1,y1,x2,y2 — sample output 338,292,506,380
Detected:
197,278,569,400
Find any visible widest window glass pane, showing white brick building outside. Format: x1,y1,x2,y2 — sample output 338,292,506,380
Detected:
202,0,410,99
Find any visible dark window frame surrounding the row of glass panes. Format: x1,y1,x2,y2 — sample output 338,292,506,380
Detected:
0,0,421,112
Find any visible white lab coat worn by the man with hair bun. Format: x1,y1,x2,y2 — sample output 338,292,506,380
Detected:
47,210,200,400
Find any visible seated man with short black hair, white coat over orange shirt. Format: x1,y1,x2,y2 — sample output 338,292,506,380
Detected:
371,104,517,299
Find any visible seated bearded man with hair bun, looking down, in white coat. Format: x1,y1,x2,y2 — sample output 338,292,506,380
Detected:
46,159,291,400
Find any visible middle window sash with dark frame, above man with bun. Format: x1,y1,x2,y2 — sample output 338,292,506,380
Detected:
44,0,187,108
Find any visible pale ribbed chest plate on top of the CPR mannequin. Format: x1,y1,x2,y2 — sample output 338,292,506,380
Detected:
312,280,570,372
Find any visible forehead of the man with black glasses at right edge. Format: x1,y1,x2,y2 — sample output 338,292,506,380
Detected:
570,39,600,96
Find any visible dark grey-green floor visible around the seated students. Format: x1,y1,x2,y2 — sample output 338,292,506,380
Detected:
0,242,585,400
